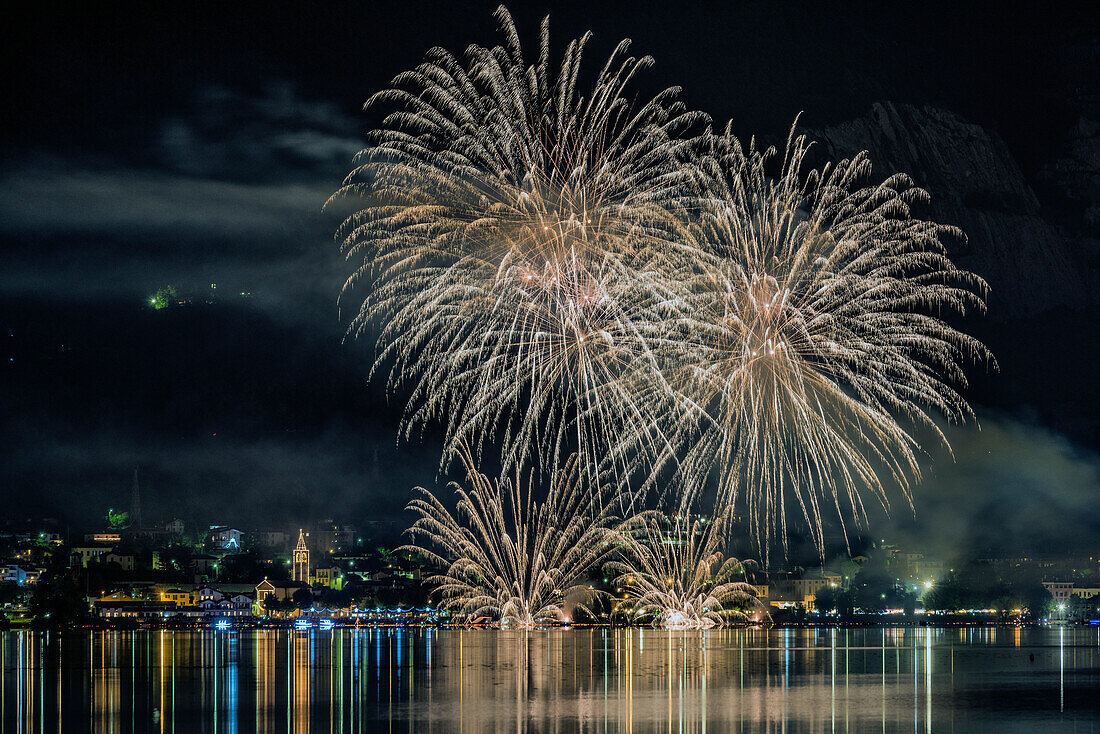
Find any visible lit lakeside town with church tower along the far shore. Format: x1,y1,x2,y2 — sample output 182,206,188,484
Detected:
0,478,1100,629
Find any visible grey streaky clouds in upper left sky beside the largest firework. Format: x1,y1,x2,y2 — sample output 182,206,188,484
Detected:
0,84,362,322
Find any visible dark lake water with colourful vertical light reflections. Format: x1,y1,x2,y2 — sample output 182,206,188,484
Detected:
0,627,1100,734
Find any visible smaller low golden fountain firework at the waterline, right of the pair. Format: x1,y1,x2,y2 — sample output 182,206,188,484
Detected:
607,511,770,628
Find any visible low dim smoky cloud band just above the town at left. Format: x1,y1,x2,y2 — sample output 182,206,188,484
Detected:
6,418,438,528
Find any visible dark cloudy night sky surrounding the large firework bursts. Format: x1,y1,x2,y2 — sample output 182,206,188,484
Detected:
0,2,1100,552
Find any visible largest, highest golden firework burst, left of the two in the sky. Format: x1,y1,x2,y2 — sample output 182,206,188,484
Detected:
327,8,705,488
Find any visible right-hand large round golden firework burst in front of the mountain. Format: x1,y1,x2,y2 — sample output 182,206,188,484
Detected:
677,128,996,561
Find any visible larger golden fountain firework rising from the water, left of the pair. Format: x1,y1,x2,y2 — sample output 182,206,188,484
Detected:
403,448,618,627
